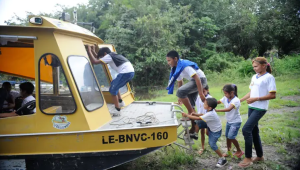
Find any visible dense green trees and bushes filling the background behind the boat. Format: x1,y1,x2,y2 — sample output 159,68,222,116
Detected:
7,0,300,87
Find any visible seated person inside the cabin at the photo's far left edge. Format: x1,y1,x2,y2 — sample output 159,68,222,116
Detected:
2,82,20,113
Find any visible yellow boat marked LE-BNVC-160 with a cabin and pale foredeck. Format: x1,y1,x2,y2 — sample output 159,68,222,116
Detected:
0,17,178,169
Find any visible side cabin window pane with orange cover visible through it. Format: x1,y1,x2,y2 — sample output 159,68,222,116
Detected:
39,53,76,114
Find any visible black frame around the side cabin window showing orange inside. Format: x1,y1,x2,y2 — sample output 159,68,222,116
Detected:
38,53,77,115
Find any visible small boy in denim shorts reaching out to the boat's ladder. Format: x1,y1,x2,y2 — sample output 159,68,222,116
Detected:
182,98,227,168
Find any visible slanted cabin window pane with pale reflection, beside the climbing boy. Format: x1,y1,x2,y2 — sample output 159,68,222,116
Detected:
68,56,104,111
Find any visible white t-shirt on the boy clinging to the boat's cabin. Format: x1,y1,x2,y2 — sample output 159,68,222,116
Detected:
100,54,134,73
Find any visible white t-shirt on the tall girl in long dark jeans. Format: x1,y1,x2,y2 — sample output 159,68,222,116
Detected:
249,73,276,110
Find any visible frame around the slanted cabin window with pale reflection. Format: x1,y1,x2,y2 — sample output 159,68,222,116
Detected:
67,55,105,112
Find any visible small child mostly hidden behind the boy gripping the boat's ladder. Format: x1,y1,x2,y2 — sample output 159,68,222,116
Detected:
190,85,212,155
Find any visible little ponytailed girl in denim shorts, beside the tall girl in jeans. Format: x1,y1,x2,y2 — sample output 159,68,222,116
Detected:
216,84,244,158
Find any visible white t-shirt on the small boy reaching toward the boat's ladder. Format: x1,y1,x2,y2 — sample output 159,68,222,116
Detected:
200,110,222,132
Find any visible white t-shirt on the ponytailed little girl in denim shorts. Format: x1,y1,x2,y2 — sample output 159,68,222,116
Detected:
220,96,242,123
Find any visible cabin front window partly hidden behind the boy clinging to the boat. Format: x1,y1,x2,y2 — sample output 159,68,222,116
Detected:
94,64,128,94
